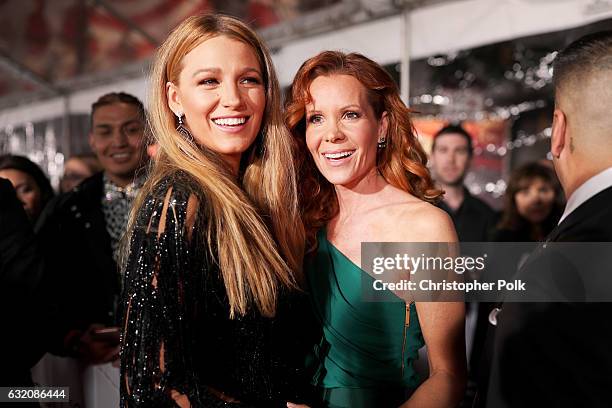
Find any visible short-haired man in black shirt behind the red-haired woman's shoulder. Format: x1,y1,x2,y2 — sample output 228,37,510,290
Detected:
430,125,497,242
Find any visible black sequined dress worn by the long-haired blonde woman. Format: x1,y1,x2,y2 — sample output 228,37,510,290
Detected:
121,176,316,408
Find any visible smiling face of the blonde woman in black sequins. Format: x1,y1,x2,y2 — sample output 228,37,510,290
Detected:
167,36,266,170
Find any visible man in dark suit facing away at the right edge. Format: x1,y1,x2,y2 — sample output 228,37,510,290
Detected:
481,31,612,408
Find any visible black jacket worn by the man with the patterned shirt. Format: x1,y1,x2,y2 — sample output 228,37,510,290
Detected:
36,173,120,354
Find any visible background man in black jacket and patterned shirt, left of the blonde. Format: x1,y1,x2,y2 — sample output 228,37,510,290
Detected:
38,93,146,364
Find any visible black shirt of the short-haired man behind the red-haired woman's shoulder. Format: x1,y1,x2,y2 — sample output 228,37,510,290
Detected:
437,188,497,242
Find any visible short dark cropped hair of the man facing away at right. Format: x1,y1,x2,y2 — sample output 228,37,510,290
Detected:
553,30,612,90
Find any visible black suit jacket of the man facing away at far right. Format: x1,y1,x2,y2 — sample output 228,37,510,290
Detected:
480,187,612,408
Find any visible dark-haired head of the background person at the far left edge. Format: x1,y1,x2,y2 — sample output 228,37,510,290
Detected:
0,154,55,224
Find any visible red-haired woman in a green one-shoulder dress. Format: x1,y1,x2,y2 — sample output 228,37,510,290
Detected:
286,51,465,408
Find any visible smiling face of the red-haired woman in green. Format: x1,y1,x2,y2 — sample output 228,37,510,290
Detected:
306,75,387,188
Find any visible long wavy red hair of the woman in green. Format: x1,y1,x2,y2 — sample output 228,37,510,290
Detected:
285,51,442,252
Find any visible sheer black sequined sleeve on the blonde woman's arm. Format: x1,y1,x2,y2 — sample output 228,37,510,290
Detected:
121,183,252,408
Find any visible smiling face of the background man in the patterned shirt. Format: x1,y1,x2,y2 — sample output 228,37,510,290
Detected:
89,102,145,187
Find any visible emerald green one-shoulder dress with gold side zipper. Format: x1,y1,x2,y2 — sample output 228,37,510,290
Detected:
306,229,424,408
